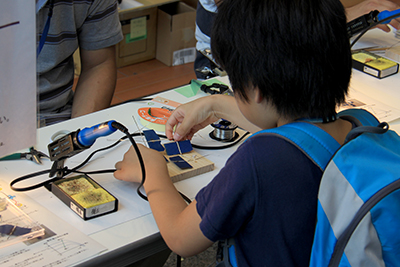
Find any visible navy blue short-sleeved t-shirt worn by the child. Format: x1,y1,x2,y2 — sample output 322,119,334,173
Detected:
196,134,322,267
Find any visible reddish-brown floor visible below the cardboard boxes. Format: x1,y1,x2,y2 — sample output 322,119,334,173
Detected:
111,59,196,105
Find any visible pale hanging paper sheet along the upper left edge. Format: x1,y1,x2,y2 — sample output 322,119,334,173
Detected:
0,0,36,157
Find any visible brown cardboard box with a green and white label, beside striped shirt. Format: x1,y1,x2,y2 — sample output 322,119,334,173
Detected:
116,7,157,67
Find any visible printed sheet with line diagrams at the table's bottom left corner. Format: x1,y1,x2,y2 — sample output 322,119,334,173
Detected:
0,180,106,266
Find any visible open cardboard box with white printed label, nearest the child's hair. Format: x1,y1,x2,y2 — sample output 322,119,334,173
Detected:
156,2,196,66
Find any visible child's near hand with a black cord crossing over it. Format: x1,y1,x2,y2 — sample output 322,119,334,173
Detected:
114,144,166,183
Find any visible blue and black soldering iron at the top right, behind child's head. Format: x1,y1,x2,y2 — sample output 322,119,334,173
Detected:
347,9,400,38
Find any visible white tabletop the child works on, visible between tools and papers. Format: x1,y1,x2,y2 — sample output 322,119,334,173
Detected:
0,76,244,266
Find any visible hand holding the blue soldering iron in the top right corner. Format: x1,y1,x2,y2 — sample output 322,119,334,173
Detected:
346,0,400,32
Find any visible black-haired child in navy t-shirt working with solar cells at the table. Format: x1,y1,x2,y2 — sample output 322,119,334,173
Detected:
114,0,352,266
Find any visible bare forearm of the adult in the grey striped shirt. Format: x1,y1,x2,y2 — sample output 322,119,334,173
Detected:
72,46,117,118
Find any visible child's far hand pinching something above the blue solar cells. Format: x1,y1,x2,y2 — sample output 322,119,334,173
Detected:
165,96,219,141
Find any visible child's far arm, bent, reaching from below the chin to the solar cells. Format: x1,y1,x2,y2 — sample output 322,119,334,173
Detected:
165,95,260,141
